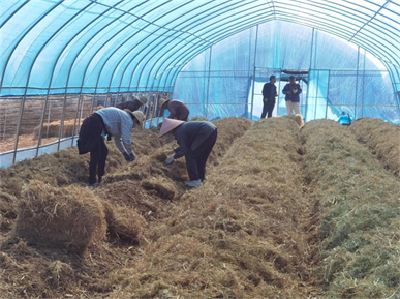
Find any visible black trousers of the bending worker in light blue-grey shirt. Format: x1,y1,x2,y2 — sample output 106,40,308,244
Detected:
78,113,107,184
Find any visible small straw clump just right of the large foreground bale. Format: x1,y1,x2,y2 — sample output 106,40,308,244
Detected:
102,201,146,245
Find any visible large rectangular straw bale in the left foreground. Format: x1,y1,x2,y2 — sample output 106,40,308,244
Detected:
16,180,106,253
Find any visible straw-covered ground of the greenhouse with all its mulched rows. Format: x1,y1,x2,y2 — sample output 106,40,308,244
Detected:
0,117,400,298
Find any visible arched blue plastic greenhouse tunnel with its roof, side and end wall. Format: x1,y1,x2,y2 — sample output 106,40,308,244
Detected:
0,0,400,168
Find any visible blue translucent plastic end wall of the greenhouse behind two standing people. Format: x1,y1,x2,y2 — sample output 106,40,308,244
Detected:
173,21,400,123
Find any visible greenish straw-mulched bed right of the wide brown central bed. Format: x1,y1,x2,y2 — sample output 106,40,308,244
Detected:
301,120,400,298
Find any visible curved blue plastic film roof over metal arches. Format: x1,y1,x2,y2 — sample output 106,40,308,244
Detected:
0,0,400,96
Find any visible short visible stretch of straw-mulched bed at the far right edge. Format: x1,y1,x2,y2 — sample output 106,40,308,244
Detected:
350,118,400,177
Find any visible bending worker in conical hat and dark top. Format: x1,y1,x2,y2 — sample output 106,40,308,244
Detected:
159,118,217,187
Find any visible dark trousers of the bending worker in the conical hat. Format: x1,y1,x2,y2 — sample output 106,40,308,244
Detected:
185,129,218,181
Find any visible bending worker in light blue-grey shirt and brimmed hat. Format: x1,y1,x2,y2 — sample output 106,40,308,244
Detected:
78,108,145,188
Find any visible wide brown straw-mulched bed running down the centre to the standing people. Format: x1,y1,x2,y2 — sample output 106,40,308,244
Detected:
110,118,313,298
